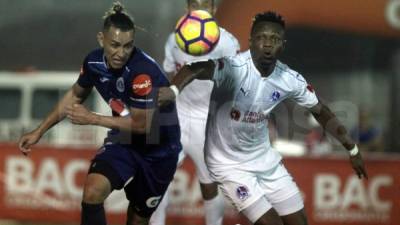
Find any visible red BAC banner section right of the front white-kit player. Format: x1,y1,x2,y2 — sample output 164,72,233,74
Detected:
285,158,400,225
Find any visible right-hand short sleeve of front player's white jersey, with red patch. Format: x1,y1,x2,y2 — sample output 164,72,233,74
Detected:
293,74,318,108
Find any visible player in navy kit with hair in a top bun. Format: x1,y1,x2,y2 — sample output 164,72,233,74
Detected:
19,3,181,225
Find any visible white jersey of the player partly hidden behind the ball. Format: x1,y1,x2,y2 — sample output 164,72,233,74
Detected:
163,27,240,120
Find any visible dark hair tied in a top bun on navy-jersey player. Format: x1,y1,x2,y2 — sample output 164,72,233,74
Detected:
103,2,135,31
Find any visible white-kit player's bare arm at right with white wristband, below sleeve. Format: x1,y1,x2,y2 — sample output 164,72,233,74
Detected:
310,101,368,179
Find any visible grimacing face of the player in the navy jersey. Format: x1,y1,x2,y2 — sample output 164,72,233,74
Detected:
98,26,135,69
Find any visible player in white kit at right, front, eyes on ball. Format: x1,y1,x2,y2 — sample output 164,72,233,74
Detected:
159,12,367,225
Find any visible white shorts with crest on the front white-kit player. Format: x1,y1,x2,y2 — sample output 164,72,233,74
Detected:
212,163,304,222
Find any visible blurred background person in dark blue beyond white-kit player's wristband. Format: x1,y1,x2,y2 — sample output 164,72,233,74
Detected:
351,108,384,152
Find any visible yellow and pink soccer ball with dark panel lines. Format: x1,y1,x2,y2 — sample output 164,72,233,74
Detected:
175,10,219,56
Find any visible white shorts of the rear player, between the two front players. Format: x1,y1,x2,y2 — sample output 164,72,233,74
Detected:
178,115,213,184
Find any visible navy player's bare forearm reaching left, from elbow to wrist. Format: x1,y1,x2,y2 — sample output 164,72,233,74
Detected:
37,89,82,136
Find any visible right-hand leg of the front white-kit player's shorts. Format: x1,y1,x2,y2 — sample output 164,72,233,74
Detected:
260,163,304,216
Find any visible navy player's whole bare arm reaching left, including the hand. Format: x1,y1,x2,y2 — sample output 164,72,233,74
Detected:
19,84,92,155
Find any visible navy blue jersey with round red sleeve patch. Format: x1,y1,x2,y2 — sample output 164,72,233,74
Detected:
77,48,180,154
